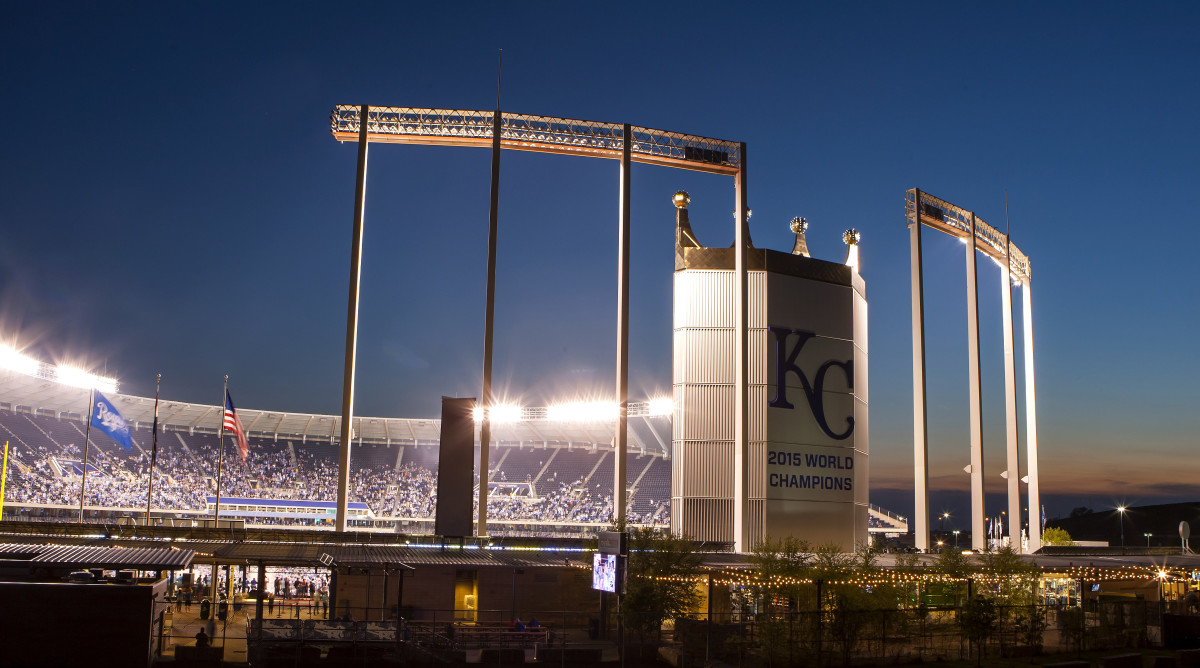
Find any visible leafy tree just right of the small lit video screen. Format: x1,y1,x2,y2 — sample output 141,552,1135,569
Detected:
622,526,701,643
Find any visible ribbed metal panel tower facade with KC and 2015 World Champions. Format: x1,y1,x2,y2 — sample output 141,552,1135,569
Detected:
672,257,869,550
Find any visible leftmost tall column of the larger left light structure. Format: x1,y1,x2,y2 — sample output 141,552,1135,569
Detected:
336,104,371,531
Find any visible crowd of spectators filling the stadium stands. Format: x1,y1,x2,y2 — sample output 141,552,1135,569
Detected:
0,413,670,524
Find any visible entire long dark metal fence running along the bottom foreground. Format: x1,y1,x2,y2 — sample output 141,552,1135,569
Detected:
147,598,1183,666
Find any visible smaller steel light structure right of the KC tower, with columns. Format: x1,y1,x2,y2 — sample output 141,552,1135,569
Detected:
905,188,1042,552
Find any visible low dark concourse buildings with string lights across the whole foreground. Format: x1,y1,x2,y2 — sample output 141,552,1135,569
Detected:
11,523,1200,666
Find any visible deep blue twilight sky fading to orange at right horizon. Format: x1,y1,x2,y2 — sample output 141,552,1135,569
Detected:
0,2,1200,517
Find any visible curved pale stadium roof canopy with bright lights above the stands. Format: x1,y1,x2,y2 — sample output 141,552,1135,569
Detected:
0,369,671,455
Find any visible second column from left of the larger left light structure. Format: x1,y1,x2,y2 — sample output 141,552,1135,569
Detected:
475,107,500,536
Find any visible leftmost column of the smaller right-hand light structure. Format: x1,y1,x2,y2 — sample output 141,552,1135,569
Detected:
908,188,929,552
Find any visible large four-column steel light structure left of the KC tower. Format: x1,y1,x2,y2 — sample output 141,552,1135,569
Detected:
330,102,750,549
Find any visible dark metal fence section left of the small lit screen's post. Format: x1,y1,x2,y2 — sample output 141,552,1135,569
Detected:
154,598,609,666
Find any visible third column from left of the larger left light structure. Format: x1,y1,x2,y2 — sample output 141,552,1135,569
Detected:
612,124,634,526
